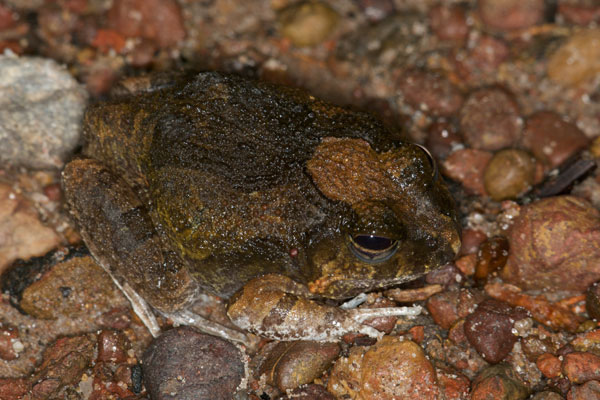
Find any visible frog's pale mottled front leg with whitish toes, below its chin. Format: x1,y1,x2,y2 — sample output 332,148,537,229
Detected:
227,274,420,342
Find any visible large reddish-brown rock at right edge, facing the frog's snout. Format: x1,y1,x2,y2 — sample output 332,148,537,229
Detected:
500,196,600,293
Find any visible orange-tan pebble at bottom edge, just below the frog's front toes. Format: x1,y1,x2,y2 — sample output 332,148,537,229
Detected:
327,336,441,400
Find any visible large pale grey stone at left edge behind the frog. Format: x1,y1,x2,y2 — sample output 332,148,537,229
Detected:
0,56,87,169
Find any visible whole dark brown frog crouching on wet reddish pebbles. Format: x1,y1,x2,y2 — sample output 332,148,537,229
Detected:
62,72,460,342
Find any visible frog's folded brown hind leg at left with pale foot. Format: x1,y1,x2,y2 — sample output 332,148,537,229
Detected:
63,159,246,342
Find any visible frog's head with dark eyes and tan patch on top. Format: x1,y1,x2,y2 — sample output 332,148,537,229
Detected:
307,138,460,298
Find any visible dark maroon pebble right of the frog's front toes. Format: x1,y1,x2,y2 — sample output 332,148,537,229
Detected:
464,299,528,364
